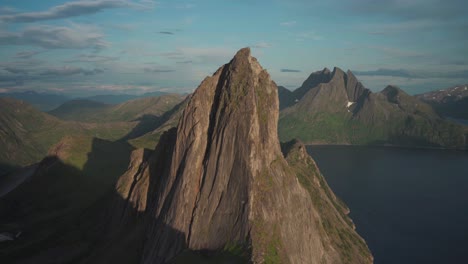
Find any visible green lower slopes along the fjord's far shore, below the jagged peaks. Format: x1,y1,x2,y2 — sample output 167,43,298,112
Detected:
278,108,466,148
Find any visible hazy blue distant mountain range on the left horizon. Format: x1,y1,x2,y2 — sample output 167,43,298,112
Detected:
0,91,171,111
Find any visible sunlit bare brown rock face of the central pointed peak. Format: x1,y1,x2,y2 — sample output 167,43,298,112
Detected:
97,49,367,263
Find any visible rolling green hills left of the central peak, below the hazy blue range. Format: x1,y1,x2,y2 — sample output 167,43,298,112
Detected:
0,95,184,175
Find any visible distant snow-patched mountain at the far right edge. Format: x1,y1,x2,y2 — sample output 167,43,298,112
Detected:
416,84,468,119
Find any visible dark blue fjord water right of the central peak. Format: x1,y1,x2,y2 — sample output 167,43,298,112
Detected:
308,146,468,264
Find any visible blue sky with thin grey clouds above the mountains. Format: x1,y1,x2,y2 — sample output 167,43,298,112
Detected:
0,0,468,96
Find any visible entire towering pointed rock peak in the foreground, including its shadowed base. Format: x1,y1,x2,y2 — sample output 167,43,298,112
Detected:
87,49,372,263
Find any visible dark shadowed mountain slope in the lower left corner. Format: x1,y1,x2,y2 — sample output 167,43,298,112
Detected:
0,138,133,263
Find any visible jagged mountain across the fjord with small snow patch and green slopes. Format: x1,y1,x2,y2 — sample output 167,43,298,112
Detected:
279,68,467,149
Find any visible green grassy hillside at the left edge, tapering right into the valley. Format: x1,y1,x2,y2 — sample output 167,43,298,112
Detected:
0,98,136,170
